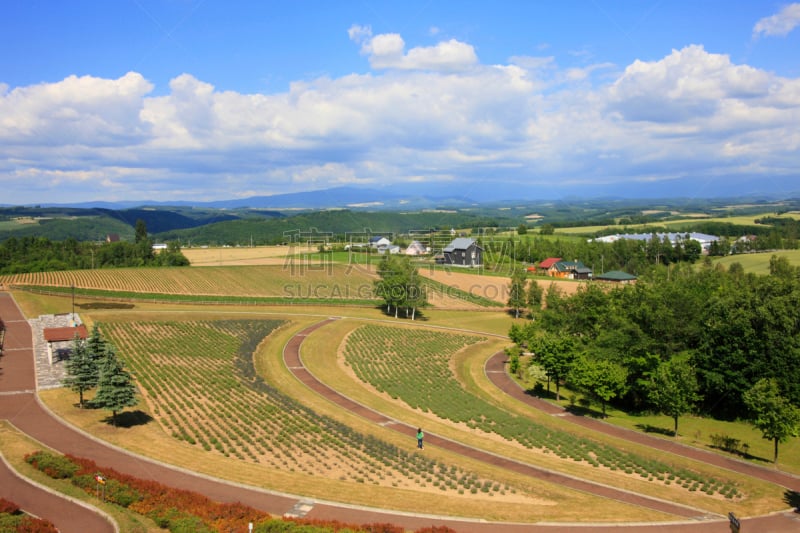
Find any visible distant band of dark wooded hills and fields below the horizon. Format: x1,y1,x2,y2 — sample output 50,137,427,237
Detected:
0,200,800,248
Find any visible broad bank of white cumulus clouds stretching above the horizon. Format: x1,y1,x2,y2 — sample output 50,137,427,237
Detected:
0,26,800,203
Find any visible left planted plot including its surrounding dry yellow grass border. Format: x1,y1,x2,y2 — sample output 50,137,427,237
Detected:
37,311,668,521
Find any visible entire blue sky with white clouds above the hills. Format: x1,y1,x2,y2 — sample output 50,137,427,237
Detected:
0,0,800,204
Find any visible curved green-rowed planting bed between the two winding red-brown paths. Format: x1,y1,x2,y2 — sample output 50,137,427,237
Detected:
344,324,743,500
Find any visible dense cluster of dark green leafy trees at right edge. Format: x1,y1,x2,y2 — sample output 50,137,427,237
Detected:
510,257,800,456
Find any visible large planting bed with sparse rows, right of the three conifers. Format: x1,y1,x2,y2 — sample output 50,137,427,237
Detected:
102,320,536,501
